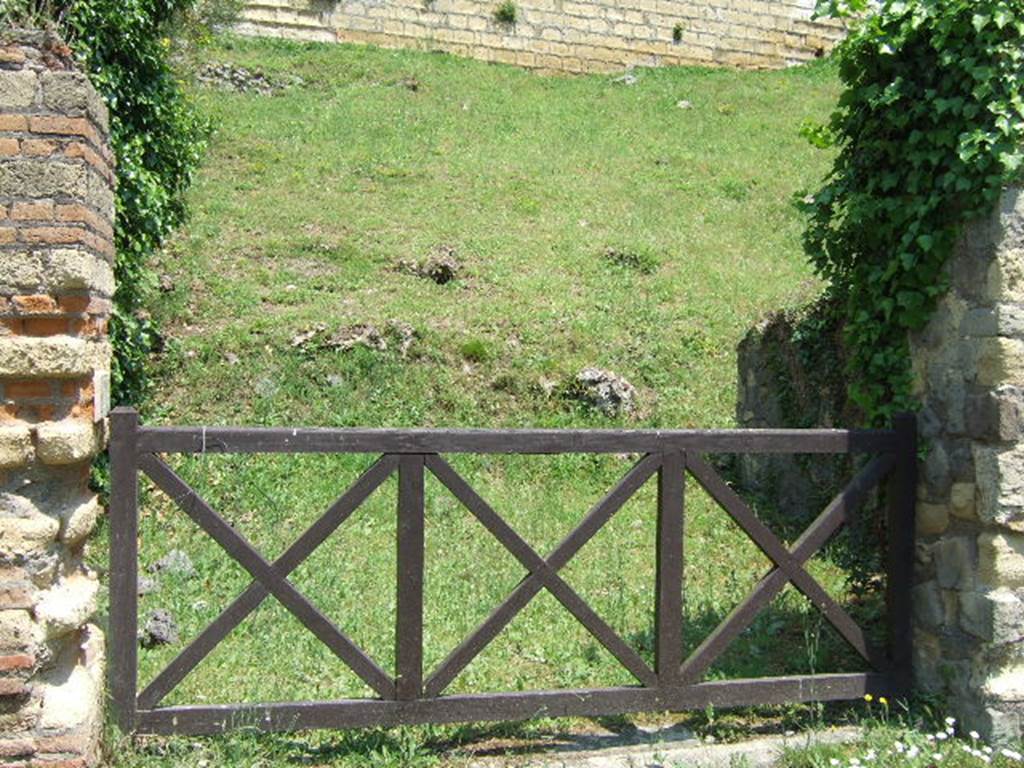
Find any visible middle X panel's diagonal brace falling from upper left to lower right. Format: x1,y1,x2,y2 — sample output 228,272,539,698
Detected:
427,455,657,686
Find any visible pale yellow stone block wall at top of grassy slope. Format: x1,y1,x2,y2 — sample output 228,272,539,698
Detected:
239,0,843,72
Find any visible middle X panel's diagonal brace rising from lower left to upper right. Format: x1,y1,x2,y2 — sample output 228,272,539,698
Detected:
424,455,662,697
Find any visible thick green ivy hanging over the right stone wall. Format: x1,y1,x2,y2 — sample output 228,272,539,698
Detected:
804,0,1024,425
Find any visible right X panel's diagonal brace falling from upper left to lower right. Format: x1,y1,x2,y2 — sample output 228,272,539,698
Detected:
684,455,889,677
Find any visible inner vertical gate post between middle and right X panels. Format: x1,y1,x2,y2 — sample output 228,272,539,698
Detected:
654,452,686,686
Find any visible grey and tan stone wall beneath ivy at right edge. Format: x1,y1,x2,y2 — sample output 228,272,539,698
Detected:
911,190,1024,738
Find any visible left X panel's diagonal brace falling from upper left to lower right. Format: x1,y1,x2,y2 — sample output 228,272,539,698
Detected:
139,454,395,698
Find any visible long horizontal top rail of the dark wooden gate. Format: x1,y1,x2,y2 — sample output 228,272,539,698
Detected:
137,427,901,454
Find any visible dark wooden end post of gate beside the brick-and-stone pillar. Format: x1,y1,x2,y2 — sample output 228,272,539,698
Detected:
110,408,138,731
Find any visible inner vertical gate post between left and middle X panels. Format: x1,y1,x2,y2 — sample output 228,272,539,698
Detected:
395,455,424,701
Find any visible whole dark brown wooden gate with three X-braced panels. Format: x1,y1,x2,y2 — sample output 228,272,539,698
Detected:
110,409,916,733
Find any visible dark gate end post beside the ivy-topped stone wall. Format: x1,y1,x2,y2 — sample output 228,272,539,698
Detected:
886,414,918,695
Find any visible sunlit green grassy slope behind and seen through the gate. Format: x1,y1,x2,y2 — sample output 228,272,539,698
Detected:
97,39,876,765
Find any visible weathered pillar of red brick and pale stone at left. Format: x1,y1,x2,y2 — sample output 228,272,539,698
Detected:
0,33,114,768
